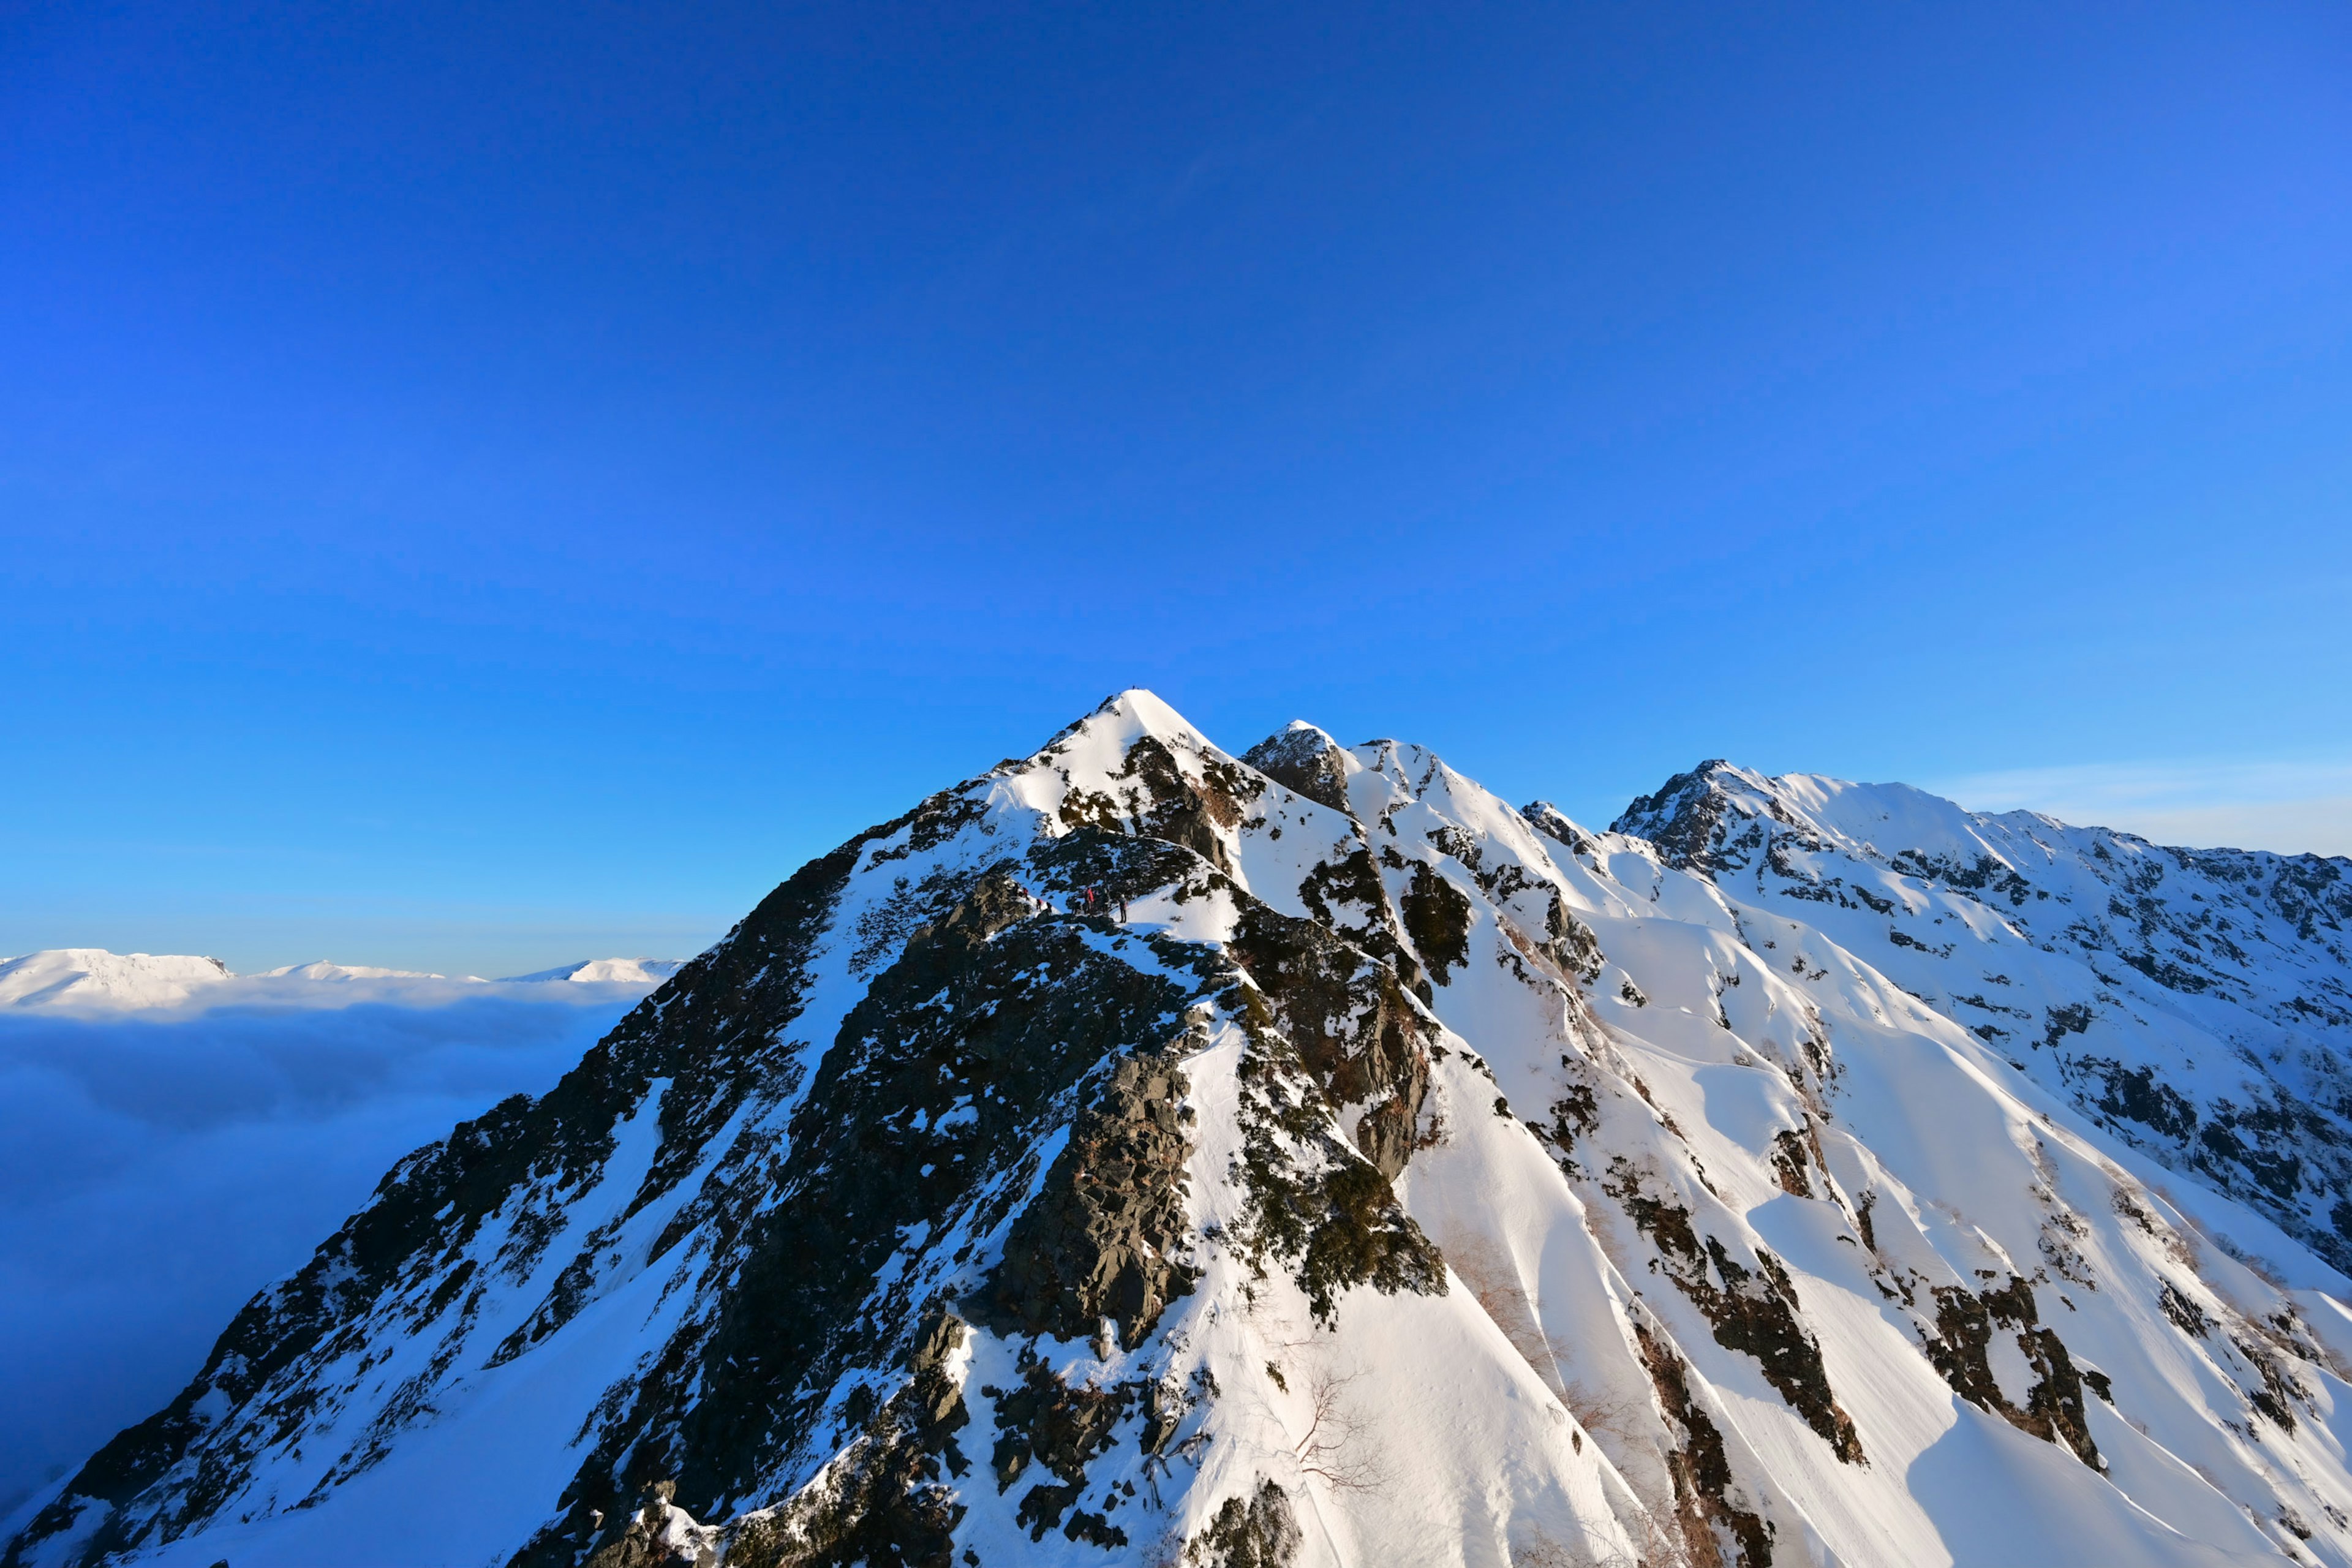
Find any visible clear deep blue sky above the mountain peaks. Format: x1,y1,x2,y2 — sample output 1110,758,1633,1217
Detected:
0,0,2352,973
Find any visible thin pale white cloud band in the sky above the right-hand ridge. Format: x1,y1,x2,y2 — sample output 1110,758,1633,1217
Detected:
1921,762,2352,856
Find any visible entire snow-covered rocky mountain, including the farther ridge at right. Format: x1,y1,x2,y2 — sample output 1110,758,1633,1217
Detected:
5,691,2352,1568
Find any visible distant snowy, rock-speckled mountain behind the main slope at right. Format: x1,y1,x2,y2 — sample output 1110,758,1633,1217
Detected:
1616,762,2352,1267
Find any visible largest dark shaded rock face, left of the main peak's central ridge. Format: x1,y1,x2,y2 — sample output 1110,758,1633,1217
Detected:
524,872,1188,1566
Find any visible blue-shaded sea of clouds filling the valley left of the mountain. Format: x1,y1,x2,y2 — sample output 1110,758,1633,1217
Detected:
0,985,642,1518
